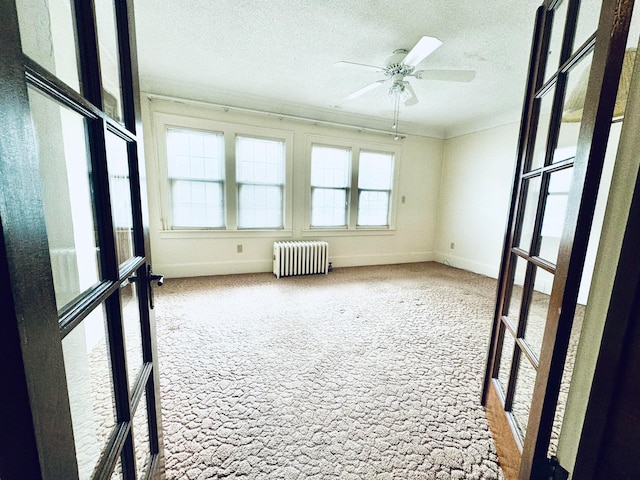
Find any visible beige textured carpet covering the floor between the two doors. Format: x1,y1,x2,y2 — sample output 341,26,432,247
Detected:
156,263,502,480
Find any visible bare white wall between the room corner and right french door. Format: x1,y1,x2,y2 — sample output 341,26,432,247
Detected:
435,123,519,278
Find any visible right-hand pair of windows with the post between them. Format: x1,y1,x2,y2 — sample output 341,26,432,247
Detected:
309,142,399,230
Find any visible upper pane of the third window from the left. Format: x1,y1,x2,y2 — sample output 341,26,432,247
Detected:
311,145,351,188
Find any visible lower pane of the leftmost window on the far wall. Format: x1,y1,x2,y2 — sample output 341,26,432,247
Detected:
171,180,224,228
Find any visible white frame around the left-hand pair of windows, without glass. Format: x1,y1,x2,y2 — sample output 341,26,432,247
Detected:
152,112,293,238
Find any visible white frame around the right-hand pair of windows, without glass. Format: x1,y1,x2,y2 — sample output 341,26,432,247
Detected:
302,135,402,237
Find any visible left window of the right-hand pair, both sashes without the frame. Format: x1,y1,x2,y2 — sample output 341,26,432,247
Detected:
311,145,351,227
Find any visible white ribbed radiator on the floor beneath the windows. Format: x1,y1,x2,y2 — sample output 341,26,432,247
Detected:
273,241,329,278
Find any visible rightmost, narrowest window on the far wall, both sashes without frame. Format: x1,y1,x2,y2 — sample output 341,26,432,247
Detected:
357,151,393,227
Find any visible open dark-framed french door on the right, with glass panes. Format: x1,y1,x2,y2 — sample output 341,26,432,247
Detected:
483,0,633,480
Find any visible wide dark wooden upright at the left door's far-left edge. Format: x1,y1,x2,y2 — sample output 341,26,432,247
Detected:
0,2,78,480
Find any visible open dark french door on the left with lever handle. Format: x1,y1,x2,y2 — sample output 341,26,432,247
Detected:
0,0,163,480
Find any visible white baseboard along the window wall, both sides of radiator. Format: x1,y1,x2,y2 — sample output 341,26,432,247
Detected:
153,252,434,278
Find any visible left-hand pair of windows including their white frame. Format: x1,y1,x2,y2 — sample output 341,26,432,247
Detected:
158,112,293,232
